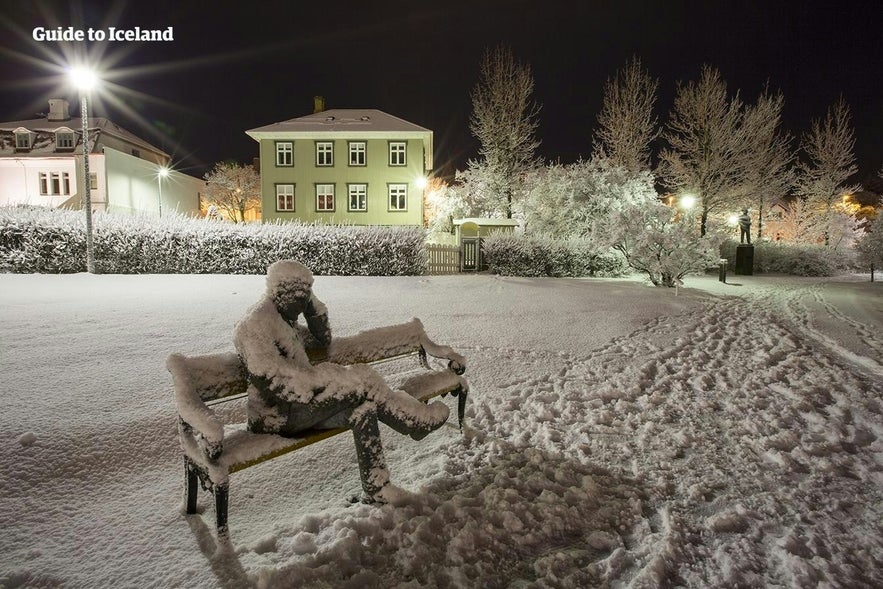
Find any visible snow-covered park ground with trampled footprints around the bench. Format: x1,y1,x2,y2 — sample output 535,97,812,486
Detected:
0,275,883,589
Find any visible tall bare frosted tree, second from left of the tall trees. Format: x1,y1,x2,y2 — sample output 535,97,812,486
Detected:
592,57,659,172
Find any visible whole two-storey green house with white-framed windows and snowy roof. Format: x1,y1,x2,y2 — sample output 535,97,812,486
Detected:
246,109,432,226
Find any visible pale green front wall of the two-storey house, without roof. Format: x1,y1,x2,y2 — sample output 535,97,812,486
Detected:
260,137,425,226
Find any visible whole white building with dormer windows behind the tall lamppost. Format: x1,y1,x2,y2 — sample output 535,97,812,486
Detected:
0,99,205,215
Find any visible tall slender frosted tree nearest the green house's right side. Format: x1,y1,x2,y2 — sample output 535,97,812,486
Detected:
469,46,540,218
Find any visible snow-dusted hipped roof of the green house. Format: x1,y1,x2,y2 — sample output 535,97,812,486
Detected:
246,108,432,139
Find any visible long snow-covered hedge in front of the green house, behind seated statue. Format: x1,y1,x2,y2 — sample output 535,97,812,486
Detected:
0,207,426,276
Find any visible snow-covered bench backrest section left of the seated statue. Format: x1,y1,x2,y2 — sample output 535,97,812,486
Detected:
166,352,248,401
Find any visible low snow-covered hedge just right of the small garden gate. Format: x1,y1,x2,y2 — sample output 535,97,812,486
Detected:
482,233,630,277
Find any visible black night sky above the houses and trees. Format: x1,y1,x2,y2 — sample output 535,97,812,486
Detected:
0,0,883,181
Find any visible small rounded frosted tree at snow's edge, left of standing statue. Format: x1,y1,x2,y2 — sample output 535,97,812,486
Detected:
602,203,721,287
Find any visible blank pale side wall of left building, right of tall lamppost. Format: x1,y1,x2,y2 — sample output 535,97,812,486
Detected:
103,147,204,216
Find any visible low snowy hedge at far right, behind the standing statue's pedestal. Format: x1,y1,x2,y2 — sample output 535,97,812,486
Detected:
721,240,853,276
